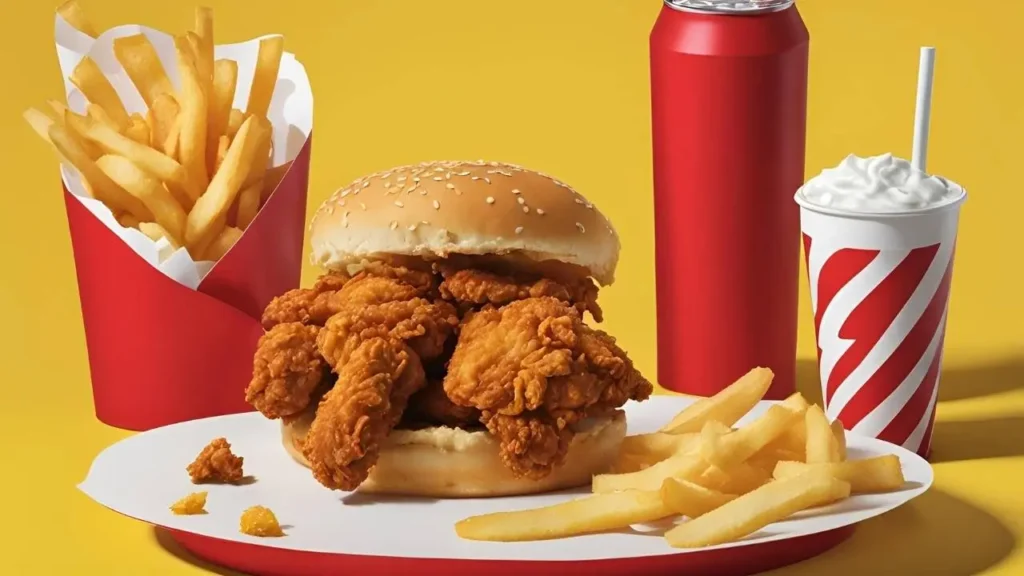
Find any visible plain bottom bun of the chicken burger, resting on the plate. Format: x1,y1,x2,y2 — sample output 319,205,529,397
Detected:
282,410,626,498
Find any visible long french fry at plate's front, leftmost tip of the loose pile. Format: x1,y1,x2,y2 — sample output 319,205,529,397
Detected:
455,490,673,542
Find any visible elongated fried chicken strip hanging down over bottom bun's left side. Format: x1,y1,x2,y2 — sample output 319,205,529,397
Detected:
303,337,425,490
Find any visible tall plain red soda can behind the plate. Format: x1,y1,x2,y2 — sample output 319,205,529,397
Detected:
650,0,810,400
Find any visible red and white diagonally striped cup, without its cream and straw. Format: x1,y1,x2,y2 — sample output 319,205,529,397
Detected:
797,186,966,457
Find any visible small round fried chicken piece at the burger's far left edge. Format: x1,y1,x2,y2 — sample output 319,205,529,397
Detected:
246,322,328,418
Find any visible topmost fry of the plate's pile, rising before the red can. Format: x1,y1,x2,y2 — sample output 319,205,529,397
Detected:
662,368,774,434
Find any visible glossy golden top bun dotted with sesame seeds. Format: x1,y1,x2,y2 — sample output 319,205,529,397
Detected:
309,161,620,285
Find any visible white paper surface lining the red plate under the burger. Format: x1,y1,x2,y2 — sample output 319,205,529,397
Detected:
79,396,933,561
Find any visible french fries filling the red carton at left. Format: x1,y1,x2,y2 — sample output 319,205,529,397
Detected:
25,0,289,261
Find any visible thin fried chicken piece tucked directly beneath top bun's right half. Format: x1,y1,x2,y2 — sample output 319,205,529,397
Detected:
439,266,603,322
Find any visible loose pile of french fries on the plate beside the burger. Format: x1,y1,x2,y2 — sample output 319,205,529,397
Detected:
456,368,904,548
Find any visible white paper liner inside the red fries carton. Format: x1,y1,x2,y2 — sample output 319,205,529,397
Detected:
54,15,313,289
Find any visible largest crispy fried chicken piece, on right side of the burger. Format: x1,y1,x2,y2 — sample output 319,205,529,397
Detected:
444,297,653,478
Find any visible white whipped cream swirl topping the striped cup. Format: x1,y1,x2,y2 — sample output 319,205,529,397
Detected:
797,154,964,212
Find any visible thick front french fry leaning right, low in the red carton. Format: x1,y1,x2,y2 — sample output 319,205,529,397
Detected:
185,117,262,247
